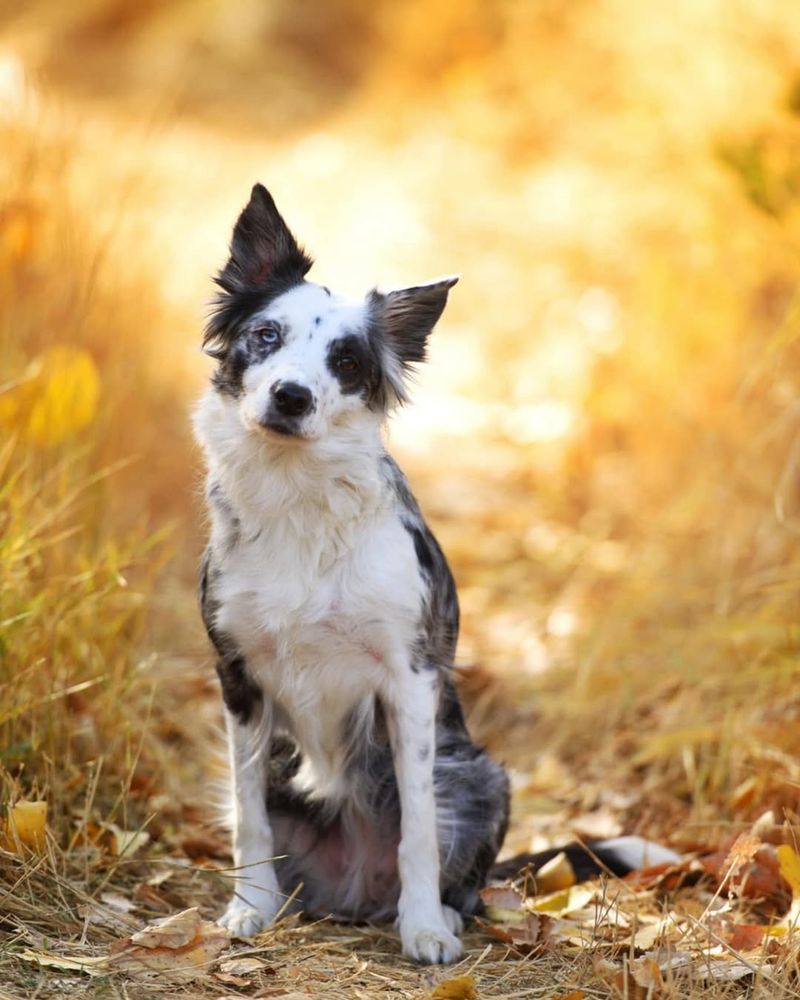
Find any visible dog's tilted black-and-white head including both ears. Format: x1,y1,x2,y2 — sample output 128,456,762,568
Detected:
204,184,458,442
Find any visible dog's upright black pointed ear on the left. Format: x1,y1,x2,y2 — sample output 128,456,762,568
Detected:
217,184,312,293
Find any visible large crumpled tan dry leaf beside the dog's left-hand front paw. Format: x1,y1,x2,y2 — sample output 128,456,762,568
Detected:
109,907,230,981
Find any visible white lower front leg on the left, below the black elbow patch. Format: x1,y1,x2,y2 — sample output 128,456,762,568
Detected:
219,706,283,937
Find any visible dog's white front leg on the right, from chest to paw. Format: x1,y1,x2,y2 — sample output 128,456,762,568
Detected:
389,663,461,962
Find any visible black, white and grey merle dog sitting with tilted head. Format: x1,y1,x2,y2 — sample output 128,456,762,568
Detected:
194,184,676,963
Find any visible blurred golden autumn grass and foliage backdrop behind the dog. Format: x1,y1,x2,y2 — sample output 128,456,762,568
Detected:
0,0,800,900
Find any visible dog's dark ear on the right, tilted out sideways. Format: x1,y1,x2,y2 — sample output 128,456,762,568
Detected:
370,276,458,403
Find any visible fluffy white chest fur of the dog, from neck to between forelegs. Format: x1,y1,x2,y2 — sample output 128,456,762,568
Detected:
195,390,425,795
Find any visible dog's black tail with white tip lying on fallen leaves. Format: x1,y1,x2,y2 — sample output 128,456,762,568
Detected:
489,837,681,882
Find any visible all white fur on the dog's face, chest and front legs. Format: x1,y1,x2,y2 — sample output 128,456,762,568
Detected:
195,285,461,962
